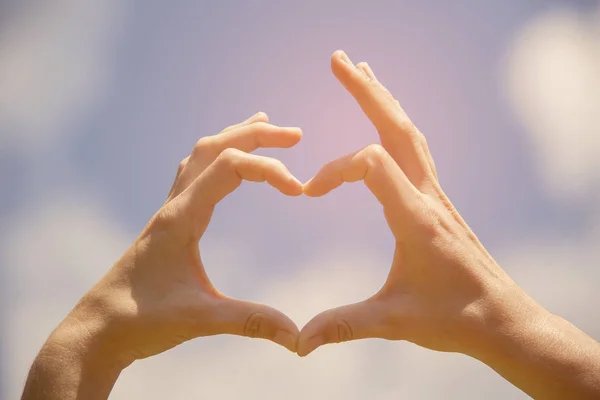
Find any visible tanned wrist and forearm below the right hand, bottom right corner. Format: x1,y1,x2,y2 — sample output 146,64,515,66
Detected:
473,312,600,399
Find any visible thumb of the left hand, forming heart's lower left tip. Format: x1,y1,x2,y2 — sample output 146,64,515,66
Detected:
215,298,299,353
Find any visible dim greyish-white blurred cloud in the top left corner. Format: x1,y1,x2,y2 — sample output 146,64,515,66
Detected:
0,0,125,151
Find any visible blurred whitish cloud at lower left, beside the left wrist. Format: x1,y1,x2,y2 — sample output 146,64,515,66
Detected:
0,192,133,399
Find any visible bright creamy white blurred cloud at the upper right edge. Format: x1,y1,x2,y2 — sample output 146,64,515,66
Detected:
506,9,600,201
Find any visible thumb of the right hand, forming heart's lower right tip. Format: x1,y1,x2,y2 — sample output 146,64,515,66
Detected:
297,299,384,357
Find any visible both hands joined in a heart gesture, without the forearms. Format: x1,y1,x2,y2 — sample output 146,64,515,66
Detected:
44,51,536,368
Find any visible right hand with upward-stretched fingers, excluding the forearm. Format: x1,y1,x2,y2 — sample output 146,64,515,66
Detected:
298,51,541,356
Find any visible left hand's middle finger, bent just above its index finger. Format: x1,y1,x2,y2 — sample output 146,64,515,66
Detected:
173,122,302,196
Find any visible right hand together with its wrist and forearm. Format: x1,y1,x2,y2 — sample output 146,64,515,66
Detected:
298,51,600,399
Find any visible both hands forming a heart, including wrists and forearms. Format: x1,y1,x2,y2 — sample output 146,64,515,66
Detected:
22,51,600,400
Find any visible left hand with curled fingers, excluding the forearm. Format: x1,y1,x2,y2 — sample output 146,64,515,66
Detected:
53,113,302,366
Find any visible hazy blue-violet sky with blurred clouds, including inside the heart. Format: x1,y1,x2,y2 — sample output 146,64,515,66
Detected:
0,0,600,400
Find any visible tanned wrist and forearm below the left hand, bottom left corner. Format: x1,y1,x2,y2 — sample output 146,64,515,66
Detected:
21,314,122,400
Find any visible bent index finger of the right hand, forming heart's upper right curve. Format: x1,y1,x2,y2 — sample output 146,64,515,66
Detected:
304,144,418,212
